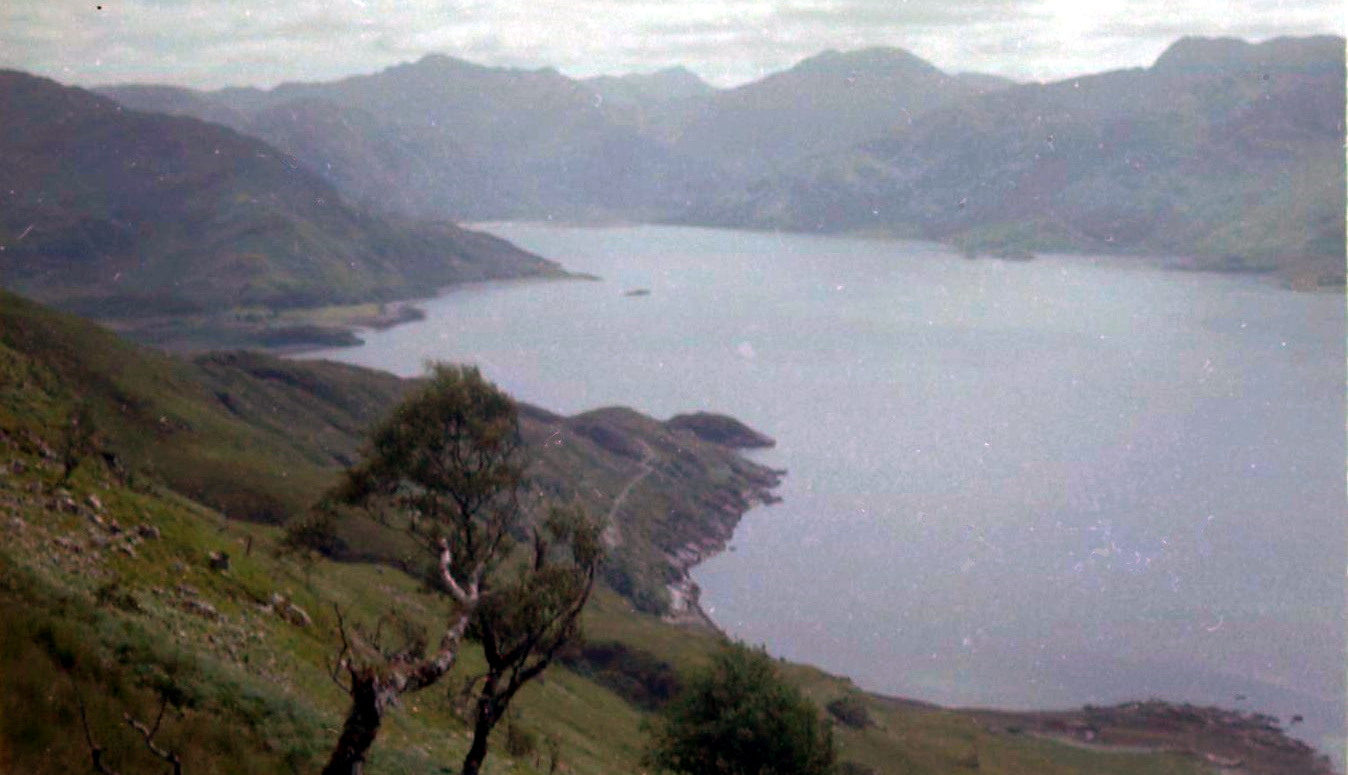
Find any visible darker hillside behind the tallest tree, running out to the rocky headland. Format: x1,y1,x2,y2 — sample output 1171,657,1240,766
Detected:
0,291,779,613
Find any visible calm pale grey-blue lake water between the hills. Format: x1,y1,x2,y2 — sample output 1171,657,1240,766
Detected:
308,224,1348,748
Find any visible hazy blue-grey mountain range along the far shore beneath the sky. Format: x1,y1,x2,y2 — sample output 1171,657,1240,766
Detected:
102,36,1344,283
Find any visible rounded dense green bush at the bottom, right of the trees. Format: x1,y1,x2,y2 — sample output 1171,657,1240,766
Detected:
648,644,837,775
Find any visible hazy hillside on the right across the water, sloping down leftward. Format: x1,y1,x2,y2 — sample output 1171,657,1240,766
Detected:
689,38,1344,282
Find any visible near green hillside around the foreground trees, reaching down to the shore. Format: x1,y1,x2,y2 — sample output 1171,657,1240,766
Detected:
0,295,1317,775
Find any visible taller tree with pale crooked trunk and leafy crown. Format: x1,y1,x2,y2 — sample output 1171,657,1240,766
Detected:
324,365,524,775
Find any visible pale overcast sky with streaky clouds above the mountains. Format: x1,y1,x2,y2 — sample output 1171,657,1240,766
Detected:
0,0,1345,88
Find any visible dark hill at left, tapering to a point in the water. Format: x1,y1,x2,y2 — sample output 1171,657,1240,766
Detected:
0,71,559,317
